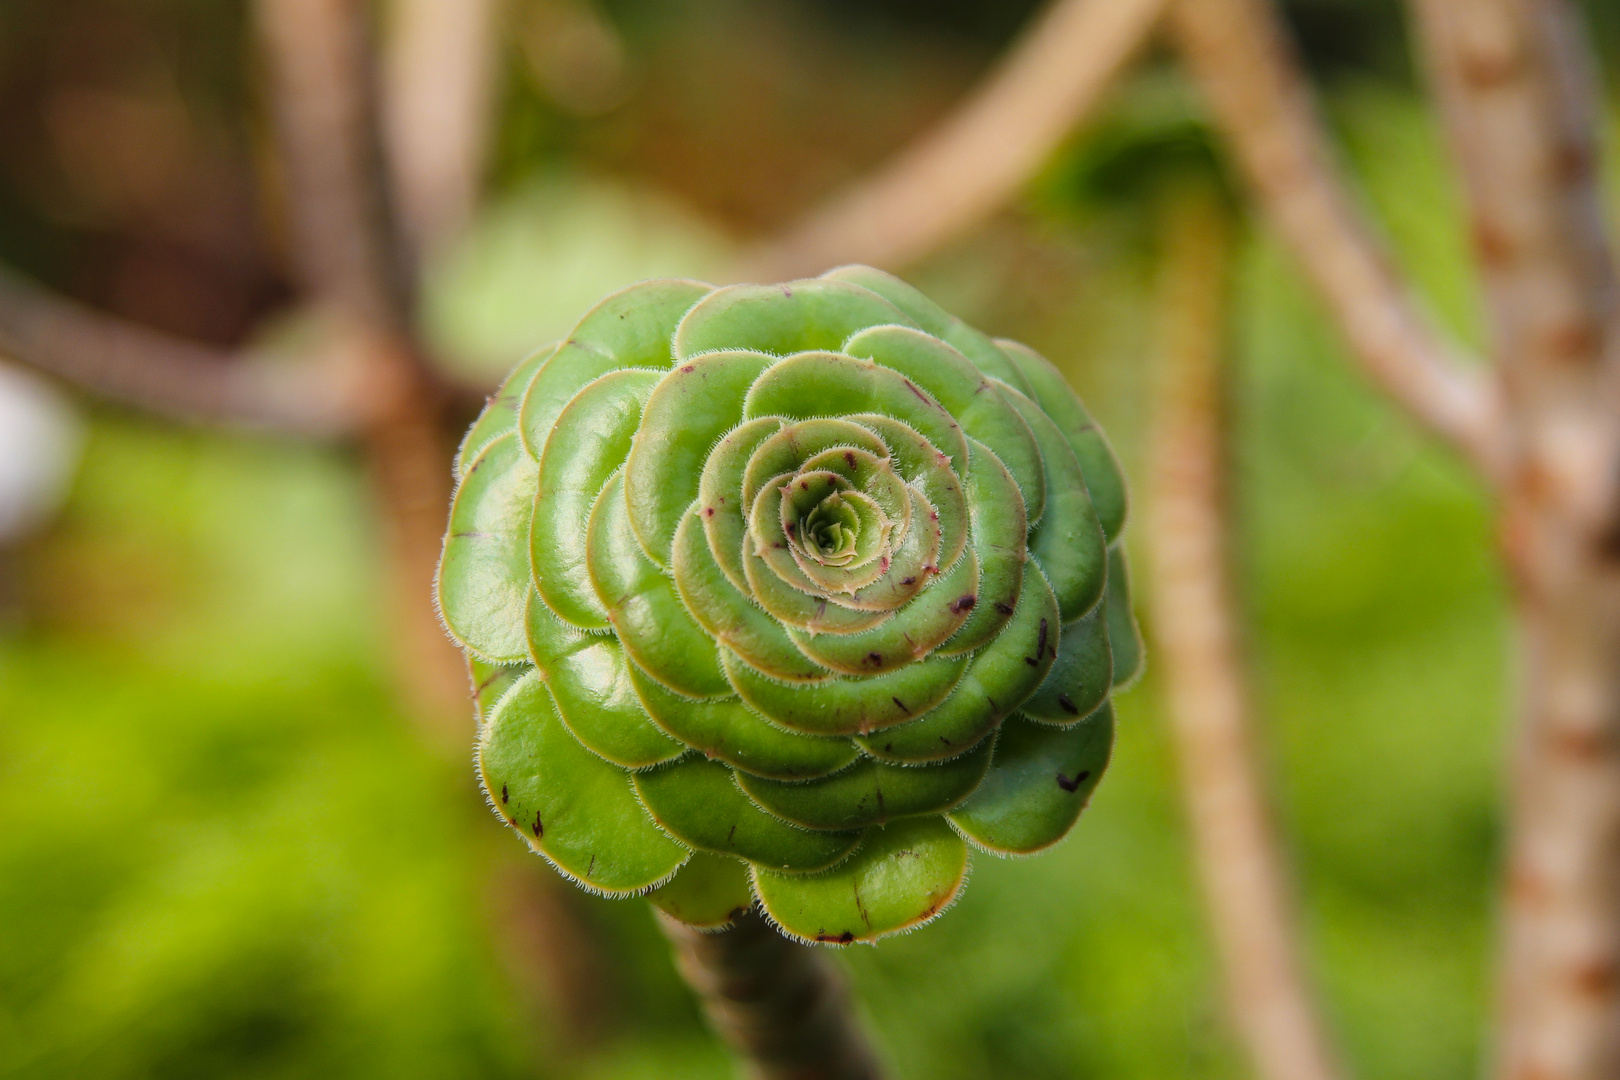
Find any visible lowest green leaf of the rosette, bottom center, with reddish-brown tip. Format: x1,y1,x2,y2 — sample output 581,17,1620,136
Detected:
753,818,967,944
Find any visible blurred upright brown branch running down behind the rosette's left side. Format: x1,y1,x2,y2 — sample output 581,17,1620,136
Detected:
256,0,467,738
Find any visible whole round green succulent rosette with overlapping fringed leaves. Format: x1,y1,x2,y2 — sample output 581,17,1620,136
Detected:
437,267,1140,942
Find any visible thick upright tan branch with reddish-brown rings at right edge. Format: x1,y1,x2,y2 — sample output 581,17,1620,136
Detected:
1414,0,1620,1080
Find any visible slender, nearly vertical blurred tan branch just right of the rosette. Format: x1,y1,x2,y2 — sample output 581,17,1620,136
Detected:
1149,185,1340,1080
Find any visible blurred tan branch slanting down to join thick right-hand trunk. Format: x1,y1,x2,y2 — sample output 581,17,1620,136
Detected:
1170,0,1500,476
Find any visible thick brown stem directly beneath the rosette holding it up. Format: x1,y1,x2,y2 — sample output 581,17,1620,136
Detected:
658,910,883,1080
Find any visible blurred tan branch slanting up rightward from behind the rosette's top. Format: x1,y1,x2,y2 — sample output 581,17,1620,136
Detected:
744,0,1165,282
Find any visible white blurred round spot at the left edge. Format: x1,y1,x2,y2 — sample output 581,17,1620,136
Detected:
0,361,84,542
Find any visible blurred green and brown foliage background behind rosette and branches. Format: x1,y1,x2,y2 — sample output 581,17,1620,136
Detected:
0,0,1620,1080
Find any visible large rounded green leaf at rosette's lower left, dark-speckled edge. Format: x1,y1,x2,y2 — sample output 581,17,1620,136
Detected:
478,670,689,895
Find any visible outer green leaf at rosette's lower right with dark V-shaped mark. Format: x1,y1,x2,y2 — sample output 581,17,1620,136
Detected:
948,704,1113,855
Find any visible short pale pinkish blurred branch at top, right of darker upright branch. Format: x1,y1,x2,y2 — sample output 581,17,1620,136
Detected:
382,0,499,264
